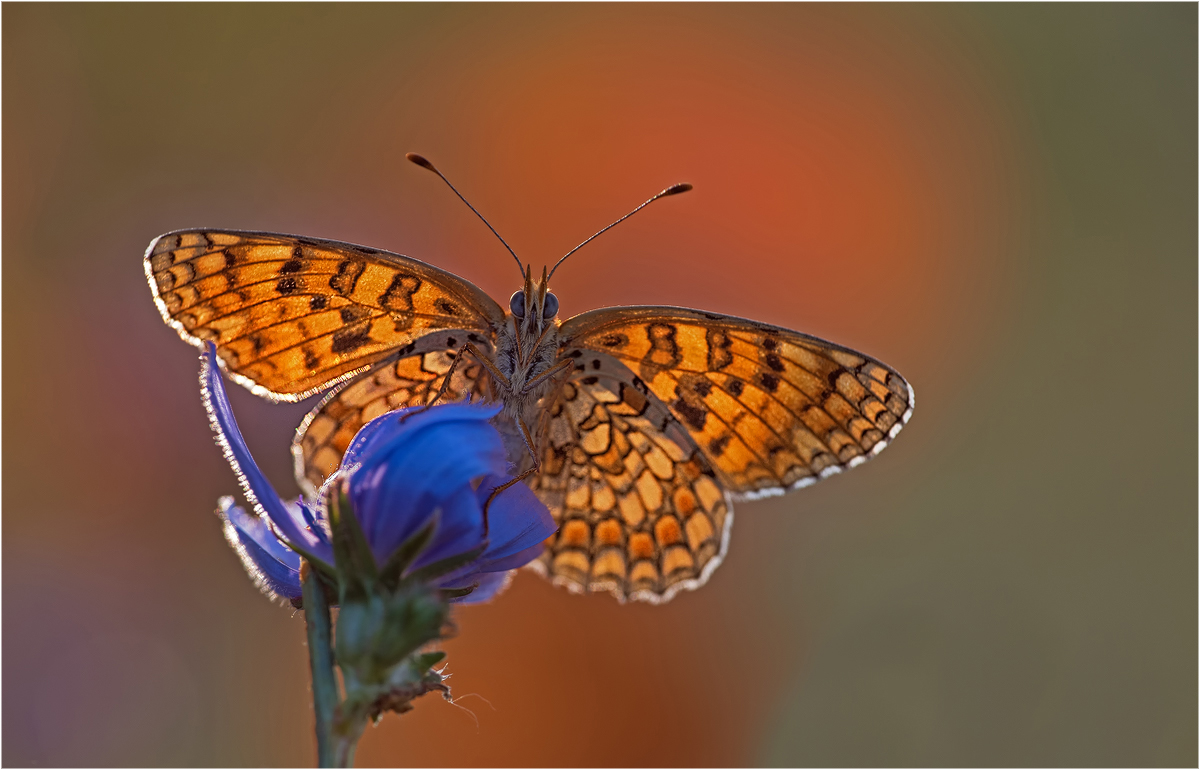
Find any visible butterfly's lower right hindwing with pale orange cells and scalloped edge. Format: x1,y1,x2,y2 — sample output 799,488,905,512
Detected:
529,350,733,602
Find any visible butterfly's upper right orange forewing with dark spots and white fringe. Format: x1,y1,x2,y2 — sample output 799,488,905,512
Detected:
559,307,913,499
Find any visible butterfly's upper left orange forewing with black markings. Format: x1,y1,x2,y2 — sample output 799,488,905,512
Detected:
145,230,504,401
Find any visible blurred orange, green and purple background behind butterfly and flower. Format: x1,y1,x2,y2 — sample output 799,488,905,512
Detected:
2,4,1198,766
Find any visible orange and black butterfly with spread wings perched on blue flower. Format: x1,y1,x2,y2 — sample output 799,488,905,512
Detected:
144,155,913,603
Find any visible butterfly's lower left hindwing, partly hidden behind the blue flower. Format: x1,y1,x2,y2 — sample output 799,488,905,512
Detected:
292,330,491,493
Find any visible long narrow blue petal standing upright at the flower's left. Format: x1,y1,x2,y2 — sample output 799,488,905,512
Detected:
200,342,334,564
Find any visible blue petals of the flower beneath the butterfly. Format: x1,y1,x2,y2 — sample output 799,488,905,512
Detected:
200,343,556,603
